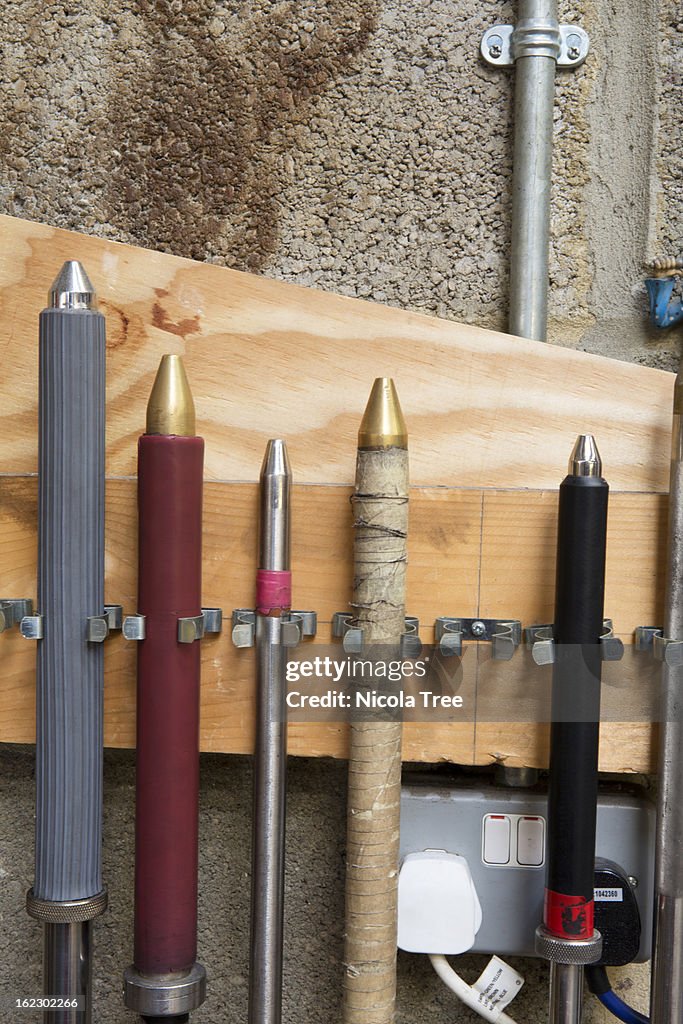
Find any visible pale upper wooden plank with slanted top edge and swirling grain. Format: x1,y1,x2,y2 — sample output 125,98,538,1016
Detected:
0,209,674,492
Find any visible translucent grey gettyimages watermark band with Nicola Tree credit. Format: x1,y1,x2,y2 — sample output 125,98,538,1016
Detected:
283,642,671,723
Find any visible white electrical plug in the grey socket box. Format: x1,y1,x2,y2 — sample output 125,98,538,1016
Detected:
398,850,481,954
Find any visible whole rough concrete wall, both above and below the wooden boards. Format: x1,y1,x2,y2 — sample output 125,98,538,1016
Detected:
0,0,683,1024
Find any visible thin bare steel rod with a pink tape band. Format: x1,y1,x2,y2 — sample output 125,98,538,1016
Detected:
249,440,292,1024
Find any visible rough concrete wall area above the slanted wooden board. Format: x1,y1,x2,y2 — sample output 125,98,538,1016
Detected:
0,0,683,350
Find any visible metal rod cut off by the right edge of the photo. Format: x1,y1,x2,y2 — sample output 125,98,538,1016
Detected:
650,371,683,1024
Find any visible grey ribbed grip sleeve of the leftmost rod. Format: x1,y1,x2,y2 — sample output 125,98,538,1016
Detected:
34,309,104,901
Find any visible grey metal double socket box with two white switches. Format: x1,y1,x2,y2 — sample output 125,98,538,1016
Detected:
400,781,654,962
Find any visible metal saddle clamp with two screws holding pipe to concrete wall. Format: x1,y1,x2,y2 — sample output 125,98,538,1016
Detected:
479,18,590,68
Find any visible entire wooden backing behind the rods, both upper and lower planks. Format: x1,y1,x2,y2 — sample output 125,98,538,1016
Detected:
0,217,674,771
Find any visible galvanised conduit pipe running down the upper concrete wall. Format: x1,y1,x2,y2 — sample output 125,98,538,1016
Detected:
509,0,560,341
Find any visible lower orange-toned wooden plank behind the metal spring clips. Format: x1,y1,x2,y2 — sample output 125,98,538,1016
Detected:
0,477,666,771
